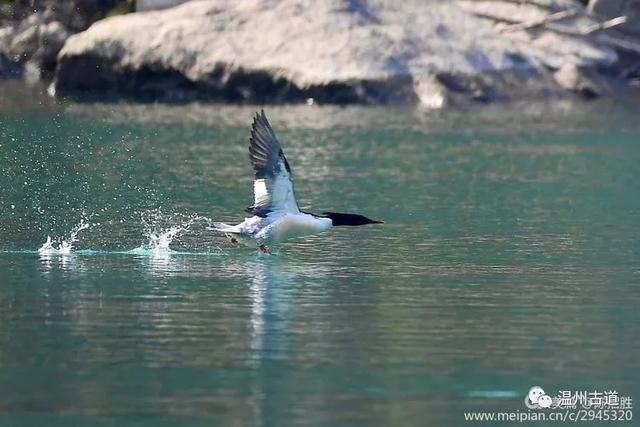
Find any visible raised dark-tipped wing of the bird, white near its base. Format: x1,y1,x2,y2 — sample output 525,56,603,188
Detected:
247,110,299,217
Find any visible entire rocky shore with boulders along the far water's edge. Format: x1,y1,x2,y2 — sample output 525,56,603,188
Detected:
0,0,640,108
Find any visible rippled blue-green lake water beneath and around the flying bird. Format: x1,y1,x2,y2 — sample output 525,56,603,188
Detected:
0,85,640,426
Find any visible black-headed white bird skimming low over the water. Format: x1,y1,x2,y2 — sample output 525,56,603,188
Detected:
209,109,384,253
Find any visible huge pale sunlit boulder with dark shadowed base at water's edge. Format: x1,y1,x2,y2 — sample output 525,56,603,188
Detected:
54,0,615,105
